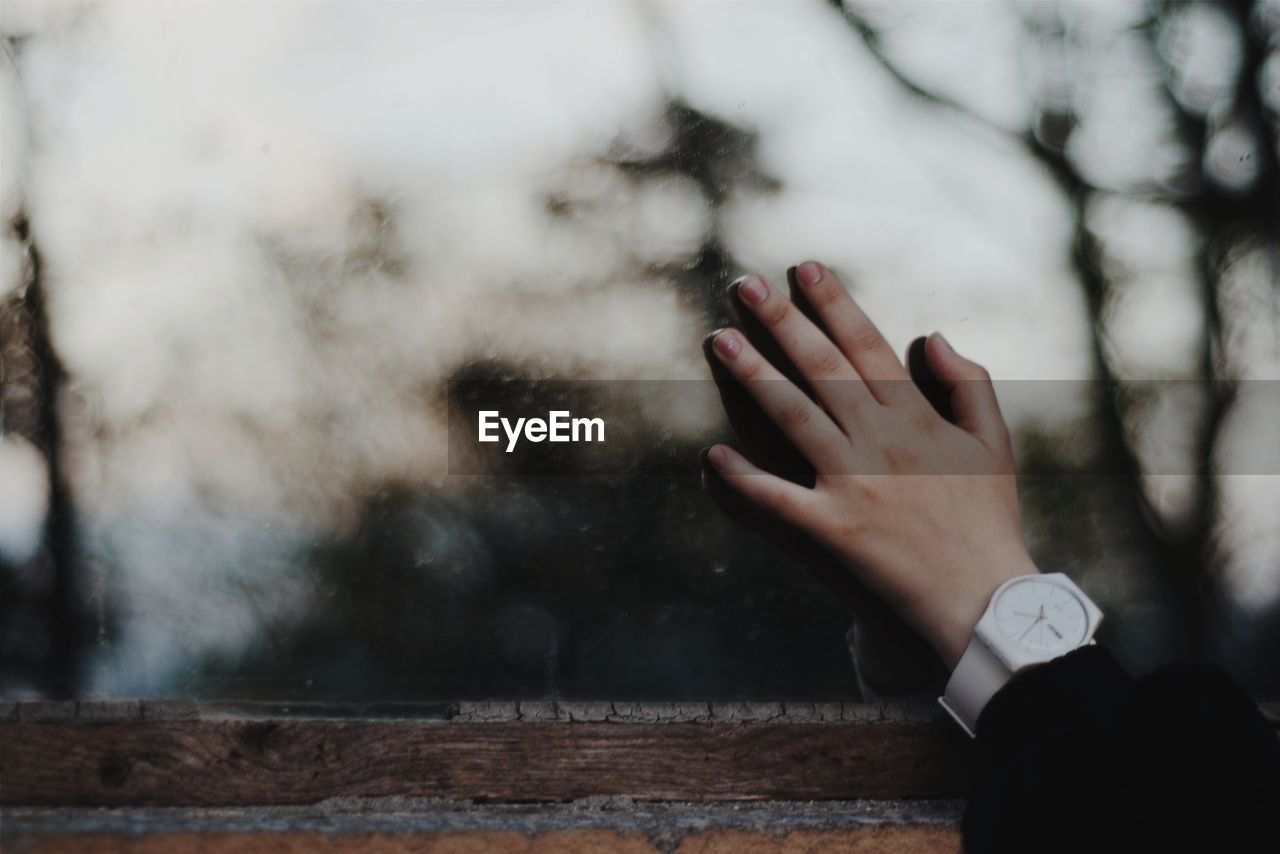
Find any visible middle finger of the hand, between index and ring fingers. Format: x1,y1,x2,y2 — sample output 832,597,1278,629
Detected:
737,275,876,433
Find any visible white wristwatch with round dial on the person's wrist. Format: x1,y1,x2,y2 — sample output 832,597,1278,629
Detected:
938,572,1102,736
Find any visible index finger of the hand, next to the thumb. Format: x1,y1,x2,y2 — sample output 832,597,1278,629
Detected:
796,261,918,405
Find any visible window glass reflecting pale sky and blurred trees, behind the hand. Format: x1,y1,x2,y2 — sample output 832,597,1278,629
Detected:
0,3,1280,703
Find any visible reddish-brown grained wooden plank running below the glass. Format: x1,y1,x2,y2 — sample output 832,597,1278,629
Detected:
0,717,965,805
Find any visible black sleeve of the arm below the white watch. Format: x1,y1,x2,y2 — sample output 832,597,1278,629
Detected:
964,647,1280,854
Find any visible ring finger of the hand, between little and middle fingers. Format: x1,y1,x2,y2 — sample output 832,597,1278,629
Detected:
712,329,849,471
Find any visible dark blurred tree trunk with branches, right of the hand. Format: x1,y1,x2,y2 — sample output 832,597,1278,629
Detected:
833,0,1280,654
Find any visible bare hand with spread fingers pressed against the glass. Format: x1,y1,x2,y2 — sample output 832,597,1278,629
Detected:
707,261,1037,667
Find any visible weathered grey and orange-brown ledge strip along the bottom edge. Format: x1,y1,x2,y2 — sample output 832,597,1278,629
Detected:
0,798,964,854
